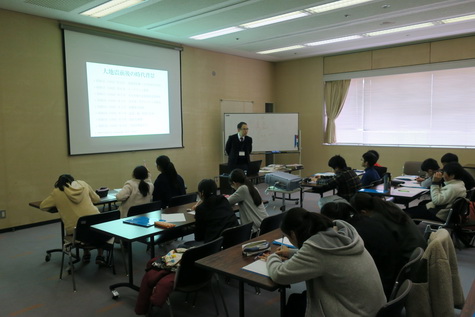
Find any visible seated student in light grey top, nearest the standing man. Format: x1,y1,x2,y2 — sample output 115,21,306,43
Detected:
228,169,269,232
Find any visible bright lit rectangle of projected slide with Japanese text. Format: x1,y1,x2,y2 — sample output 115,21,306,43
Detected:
86,62,170,137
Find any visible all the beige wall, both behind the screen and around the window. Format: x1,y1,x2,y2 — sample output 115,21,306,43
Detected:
0,10,475,229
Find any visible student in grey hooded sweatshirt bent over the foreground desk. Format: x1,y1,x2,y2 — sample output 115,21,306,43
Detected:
267,208,386,317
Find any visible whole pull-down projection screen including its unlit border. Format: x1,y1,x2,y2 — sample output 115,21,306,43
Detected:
63,25,183,155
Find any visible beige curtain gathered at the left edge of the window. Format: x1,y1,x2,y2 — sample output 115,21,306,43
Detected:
324,79,351,143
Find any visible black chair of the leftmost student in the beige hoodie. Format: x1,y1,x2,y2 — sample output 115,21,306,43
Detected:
59,210,120,291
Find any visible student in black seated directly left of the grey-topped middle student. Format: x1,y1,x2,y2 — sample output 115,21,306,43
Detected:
186,179,239,246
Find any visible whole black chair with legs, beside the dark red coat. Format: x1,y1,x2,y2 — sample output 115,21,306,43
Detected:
161,237,229,317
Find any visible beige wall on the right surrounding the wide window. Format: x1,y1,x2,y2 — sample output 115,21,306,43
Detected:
275,37,475,175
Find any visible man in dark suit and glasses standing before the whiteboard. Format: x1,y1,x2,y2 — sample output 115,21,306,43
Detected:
226,122,252,171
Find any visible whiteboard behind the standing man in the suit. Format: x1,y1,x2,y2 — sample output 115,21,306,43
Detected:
224,113,299,152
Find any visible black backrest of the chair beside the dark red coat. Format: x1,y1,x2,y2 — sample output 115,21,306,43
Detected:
175,237,223,291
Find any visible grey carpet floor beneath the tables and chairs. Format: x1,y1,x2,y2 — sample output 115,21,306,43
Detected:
0,184,475,317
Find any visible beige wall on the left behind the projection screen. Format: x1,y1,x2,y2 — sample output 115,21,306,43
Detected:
0,10,274,229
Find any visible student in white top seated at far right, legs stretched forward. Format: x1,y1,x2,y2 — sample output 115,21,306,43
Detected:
405,163,467,221
